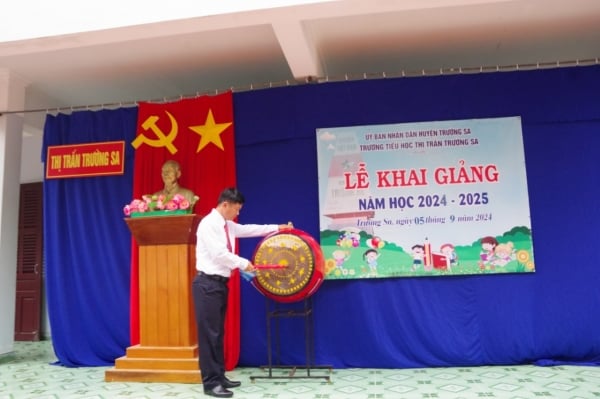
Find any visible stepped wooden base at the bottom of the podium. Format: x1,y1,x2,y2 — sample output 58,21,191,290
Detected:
104,345,202,384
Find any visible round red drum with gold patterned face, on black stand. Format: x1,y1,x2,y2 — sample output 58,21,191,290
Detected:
252,229,325,302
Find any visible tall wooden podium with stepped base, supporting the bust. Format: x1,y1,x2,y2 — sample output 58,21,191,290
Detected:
105,214,202,383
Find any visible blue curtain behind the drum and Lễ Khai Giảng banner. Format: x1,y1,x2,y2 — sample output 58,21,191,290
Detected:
234,66,600,368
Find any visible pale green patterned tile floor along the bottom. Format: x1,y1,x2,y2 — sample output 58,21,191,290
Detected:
0,341,600,399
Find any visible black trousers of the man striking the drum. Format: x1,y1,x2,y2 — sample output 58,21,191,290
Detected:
192,274,229,389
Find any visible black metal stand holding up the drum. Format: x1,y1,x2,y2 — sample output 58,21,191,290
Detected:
250,297,333,382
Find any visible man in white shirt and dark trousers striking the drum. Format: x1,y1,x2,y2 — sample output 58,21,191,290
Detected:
192,188,293,398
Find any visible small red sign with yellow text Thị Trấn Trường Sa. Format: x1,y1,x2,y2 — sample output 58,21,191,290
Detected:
46,141,125,179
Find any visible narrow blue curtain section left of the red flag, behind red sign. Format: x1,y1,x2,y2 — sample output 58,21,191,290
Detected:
42,108,137,366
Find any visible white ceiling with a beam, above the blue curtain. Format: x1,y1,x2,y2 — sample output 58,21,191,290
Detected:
0,0,600,133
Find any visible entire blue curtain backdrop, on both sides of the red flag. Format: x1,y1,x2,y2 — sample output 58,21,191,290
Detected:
44,66,600,368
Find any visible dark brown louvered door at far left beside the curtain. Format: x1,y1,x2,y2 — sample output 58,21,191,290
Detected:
15,183,43,341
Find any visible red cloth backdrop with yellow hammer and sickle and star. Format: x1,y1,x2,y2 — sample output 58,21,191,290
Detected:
130,92,240,370
